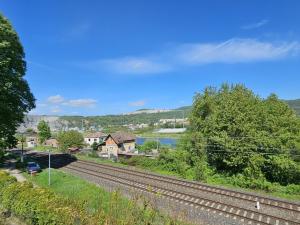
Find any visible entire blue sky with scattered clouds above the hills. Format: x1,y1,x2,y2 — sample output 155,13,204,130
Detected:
0,0,300,115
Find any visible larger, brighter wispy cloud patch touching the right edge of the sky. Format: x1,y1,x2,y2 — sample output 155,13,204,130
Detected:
177,39,300,64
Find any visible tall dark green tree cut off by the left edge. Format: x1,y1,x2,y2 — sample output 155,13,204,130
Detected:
0,14,35,149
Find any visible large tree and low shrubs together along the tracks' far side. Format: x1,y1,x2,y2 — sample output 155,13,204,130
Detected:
123,84,300,194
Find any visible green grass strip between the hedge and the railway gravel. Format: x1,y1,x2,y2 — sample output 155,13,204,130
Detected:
25,169,190,225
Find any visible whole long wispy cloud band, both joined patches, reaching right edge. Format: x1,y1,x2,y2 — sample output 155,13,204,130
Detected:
81,38,300,75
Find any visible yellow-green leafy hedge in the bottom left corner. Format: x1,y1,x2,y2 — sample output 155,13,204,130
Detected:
0,171,93,225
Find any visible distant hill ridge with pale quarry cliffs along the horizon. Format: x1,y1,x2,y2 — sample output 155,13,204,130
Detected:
19,99,300,131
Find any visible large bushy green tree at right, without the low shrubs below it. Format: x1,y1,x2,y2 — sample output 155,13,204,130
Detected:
187,84,300,183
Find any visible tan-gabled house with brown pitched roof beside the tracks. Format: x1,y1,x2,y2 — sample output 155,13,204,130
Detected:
100,132,135,158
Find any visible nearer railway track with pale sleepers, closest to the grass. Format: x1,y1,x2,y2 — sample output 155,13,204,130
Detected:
31,153,300,225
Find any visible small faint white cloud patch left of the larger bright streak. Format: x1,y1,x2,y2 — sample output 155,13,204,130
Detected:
89,57,172,74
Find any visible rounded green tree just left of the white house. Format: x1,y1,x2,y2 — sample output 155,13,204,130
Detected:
57,130,84,152
